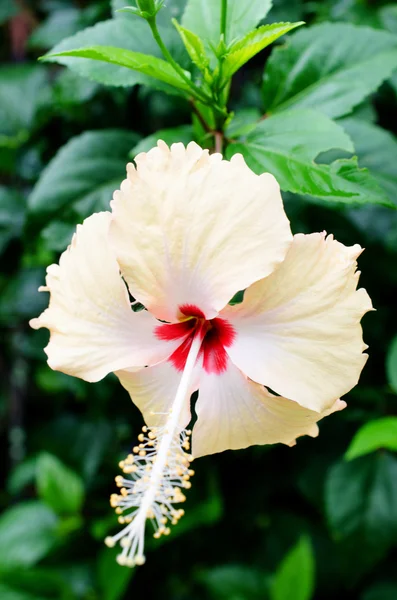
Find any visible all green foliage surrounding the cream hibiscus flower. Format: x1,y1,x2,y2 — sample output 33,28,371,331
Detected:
0,0,397,600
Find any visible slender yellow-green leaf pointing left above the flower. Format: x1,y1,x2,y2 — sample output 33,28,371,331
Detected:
42,46,190,92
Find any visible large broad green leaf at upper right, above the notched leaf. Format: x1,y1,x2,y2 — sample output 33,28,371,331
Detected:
263,23,397,117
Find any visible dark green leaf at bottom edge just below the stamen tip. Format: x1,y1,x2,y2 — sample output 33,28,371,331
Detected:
97,548,134,600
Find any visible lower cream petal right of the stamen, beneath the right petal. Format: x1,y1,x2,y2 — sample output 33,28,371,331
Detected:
192,361,346,457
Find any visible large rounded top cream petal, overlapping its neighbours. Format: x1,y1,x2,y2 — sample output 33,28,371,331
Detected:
110,141,292,321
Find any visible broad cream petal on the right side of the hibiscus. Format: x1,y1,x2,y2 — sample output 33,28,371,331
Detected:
222,233,372,412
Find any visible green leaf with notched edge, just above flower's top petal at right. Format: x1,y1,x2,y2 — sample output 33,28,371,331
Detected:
226,109,394,206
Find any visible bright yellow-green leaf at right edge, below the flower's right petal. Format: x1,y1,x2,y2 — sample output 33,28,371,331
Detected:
345,417,397,460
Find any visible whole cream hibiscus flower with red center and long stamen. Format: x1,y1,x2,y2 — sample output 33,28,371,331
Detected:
31,141,372,566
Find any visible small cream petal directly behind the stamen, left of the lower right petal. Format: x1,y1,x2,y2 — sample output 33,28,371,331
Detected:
116,361,198,429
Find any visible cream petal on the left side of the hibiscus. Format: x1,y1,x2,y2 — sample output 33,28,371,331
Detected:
30,212,180,381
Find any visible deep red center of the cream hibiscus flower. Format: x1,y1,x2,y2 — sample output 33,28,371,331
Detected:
155,304,236,374
